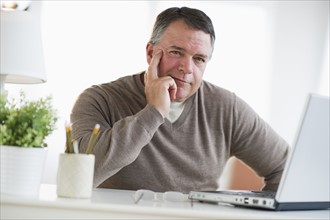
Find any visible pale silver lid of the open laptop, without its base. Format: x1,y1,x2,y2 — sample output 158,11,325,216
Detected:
276,94,330,202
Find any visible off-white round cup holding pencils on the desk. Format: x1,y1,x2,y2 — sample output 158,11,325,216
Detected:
56,153,95,198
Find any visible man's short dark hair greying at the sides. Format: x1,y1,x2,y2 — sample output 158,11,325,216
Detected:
149,7,215,48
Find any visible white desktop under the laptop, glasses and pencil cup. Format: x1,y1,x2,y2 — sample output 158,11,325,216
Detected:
1,185,330,219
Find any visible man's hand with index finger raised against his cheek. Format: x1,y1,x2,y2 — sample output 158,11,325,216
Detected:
144,50,177,118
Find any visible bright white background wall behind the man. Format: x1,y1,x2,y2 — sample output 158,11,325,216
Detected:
6,1,329,185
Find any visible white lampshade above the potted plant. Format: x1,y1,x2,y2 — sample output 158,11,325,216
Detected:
0,1,46,92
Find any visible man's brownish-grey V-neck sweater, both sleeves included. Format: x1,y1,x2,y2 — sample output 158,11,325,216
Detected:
71,74,288,192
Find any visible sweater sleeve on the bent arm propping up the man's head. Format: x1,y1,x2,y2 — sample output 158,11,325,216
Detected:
71,88,164,187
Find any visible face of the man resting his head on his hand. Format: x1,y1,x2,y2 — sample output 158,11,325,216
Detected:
147,20,212,102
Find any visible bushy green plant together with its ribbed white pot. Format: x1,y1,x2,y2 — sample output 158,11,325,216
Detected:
0,91,58,196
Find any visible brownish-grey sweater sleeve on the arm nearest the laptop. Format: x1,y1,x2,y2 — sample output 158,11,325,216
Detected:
231,97,289,191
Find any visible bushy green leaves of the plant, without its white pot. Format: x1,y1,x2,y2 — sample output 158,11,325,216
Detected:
0,92,58,147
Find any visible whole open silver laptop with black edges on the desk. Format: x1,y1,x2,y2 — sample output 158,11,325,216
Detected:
189,94,330,211
